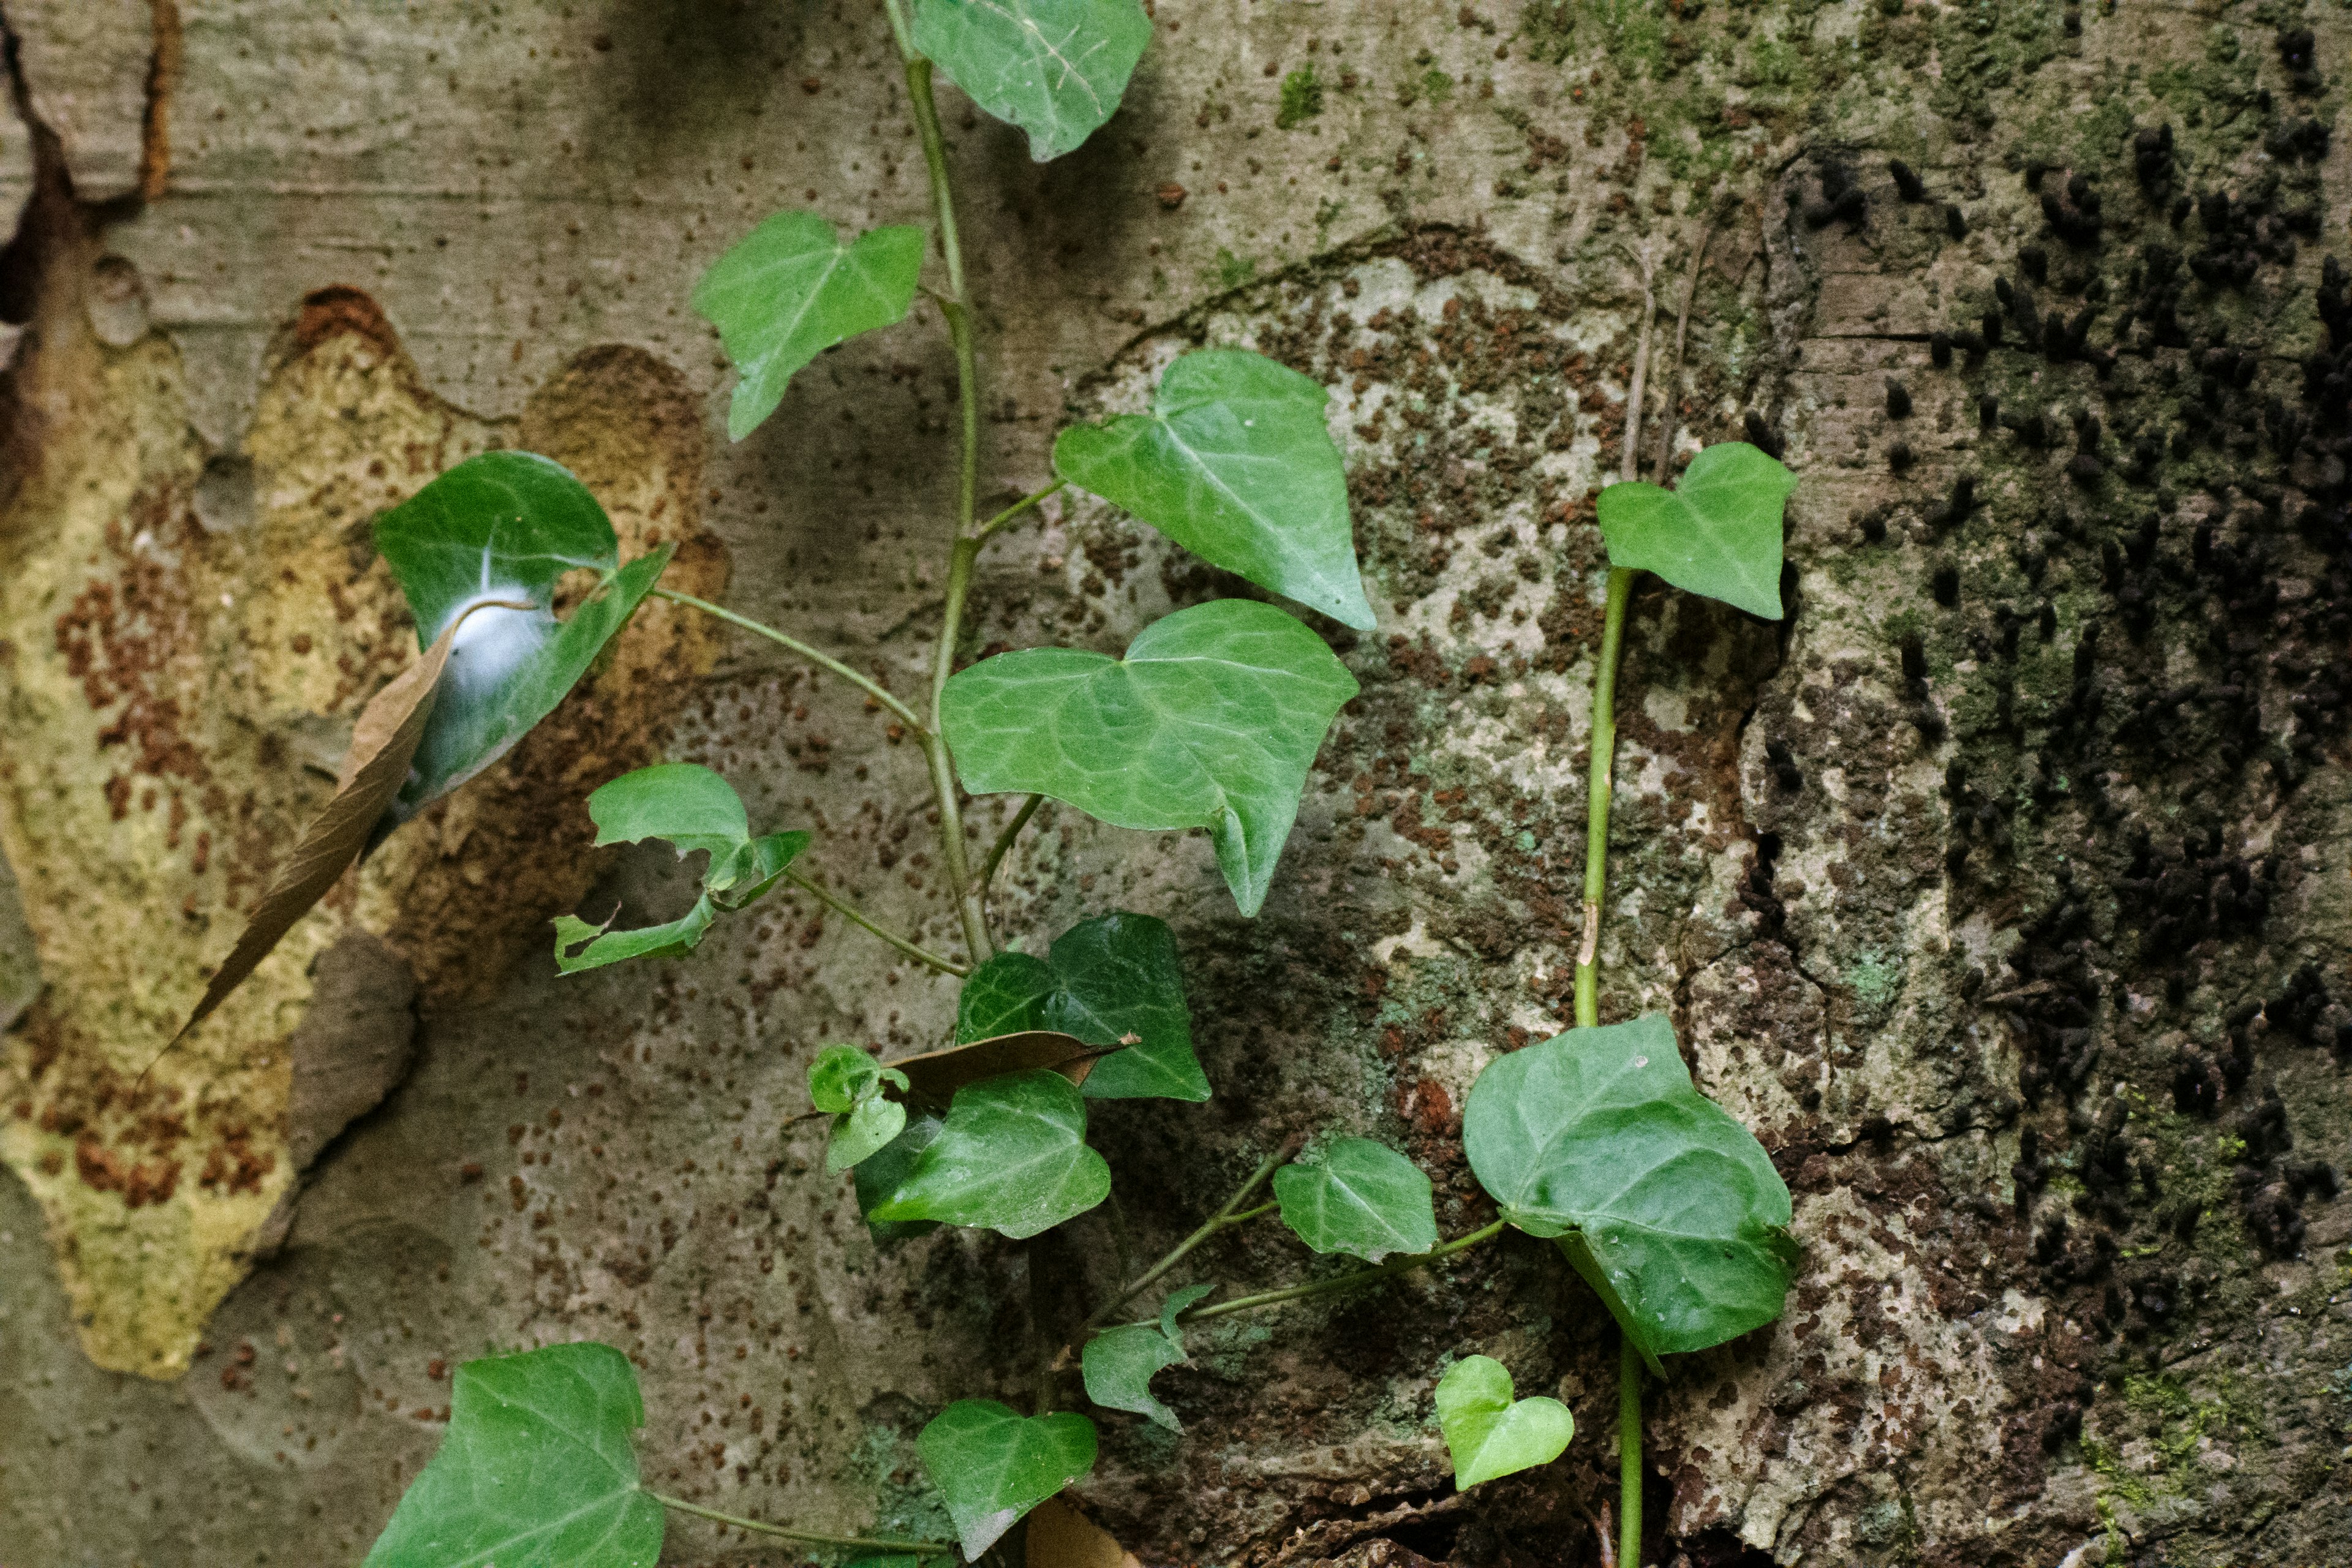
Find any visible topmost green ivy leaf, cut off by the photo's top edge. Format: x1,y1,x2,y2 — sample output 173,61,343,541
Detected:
915,0,1153,162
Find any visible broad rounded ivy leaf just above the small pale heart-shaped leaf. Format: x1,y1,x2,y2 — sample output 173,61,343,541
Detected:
1463,1013,1797,1366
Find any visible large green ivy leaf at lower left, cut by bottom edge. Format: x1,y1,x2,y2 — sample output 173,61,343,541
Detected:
367,1344,663,1568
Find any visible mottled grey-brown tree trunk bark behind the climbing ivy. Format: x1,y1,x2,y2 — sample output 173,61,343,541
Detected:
0,0,2352,1568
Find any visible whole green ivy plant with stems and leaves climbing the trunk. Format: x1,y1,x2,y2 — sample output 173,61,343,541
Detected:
275,0,1795,1568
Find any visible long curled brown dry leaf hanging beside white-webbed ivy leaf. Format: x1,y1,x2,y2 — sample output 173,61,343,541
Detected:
172,602,529,1046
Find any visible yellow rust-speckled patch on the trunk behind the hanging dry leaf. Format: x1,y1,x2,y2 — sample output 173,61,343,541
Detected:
0,289,725,1378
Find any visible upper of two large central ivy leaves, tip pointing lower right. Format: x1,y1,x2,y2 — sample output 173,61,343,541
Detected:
1054,348,1376,632
